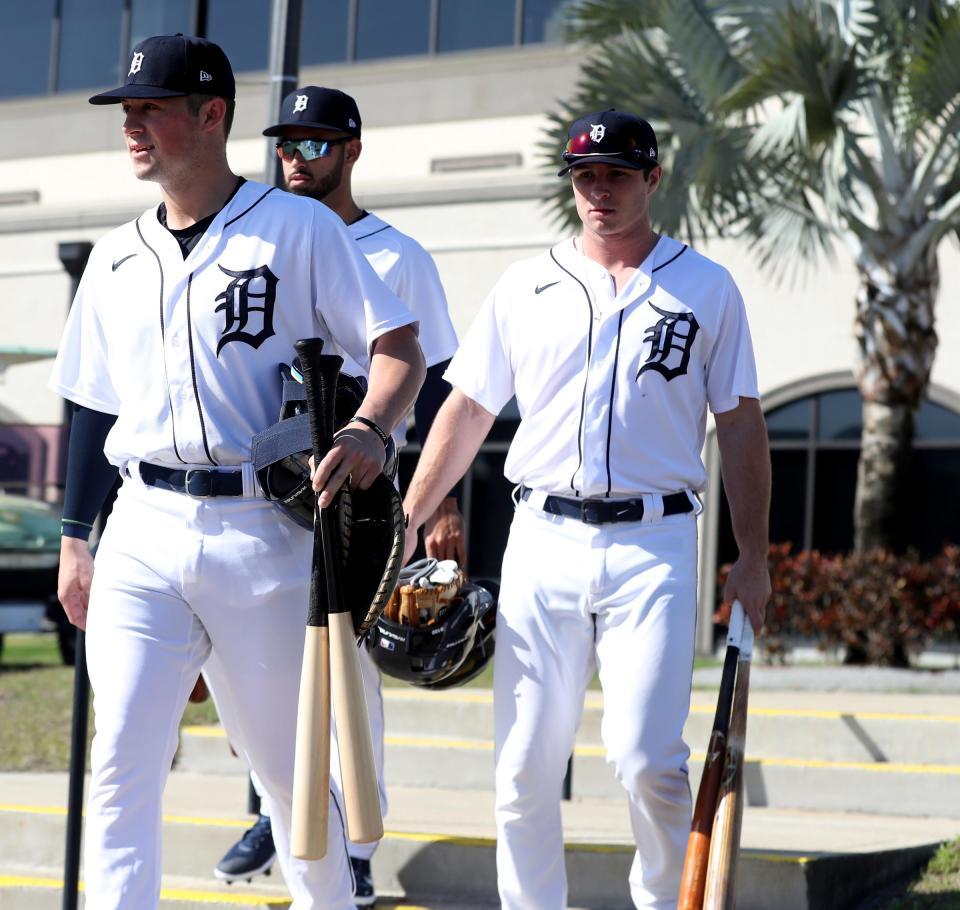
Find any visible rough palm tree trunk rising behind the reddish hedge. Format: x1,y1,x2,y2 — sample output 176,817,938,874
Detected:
854,248,940,551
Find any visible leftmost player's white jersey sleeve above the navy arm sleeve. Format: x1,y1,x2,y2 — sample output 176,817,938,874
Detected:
48,245,120,415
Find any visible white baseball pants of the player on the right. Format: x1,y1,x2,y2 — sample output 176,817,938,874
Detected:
494,502,699,910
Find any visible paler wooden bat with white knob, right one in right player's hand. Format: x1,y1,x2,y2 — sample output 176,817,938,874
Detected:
703,620,753,910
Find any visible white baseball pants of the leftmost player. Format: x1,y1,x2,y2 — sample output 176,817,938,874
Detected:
85,475,353,910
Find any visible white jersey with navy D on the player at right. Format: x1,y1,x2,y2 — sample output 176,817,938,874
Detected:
446,237,759,499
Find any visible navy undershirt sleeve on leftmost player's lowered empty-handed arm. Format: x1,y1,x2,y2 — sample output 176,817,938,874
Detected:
62,404,117,540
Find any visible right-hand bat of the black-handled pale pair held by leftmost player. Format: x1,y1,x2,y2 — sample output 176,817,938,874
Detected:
294,338,383,855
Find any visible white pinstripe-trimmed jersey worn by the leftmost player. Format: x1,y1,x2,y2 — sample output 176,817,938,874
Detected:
50,182,414,467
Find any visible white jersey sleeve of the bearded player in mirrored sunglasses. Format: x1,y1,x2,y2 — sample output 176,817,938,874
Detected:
391,240,457,367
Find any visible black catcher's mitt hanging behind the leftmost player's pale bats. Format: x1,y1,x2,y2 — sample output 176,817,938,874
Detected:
334,474,404,640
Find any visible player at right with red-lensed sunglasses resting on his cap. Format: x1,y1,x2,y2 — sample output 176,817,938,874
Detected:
405,110,770,910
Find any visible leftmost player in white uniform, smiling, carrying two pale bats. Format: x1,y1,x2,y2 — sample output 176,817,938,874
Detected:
51,35,424,910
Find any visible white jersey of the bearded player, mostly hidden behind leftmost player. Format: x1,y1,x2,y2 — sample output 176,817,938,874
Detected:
343,213,457,448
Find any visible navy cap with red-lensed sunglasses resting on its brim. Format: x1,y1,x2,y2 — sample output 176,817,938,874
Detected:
557,108,659,177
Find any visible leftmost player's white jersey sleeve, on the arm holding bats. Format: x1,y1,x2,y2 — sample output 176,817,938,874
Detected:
312,203,418,370
